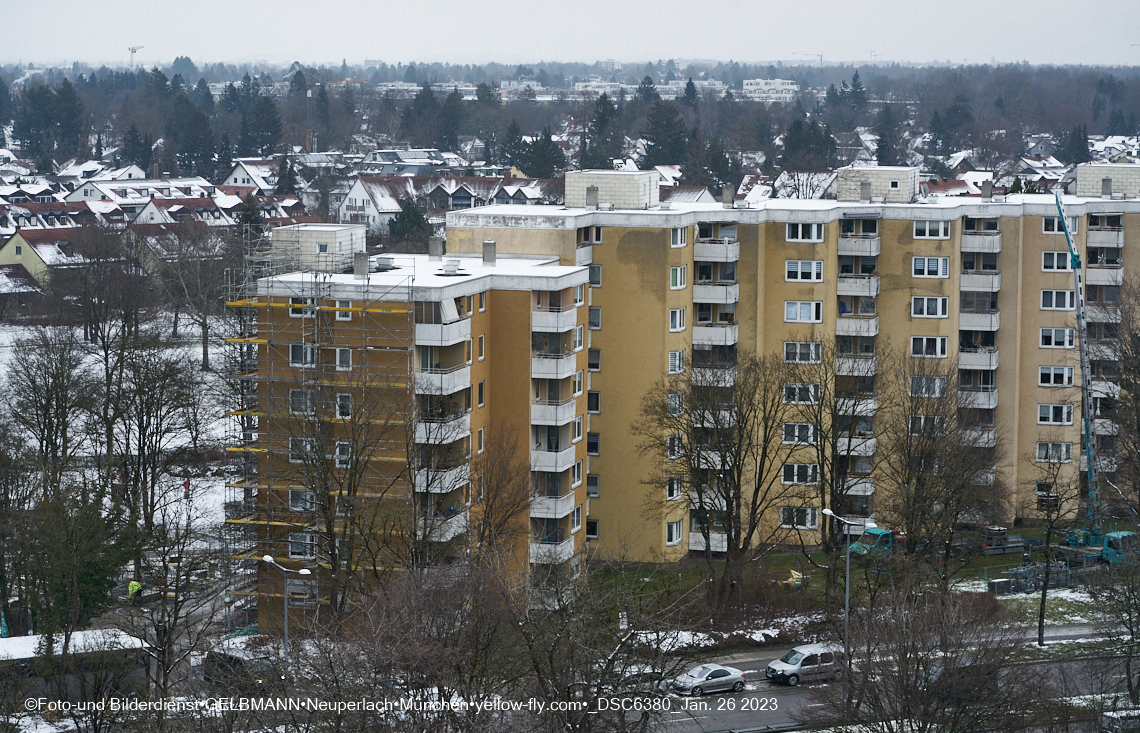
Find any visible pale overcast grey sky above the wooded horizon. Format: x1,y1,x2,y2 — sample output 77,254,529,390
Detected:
8,0,1140,66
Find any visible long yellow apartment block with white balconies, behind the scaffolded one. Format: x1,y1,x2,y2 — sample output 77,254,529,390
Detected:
447,164,1140,561
